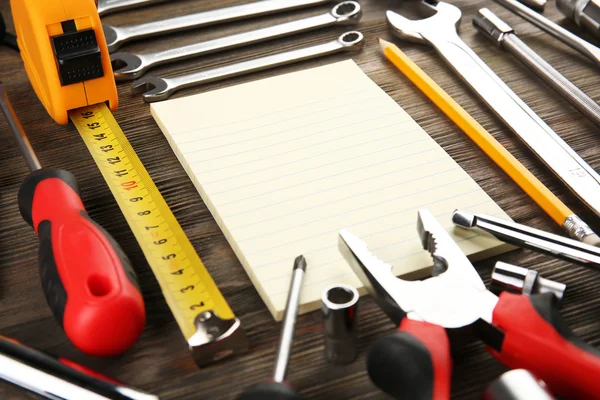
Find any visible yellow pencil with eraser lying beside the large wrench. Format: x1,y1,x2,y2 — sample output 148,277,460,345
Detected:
379,39,600,246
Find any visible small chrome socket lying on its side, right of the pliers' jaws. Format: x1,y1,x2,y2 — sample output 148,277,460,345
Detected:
489,261,567,301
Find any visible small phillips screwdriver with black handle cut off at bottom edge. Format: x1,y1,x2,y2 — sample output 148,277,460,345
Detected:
237,256,306,400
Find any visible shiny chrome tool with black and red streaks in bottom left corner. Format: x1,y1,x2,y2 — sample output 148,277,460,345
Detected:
0,336,158,400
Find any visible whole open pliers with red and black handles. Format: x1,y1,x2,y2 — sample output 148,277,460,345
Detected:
339,210,600,400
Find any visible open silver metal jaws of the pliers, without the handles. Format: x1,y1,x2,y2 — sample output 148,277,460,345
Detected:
339,210,498,328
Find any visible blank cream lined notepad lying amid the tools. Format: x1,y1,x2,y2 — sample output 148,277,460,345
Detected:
152,61,510,319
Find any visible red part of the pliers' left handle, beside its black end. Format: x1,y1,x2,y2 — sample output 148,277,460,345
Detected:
399,318,452,400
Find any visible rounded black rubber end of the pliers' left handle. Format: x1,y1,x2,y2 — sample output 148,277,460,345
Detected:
367,332,434,400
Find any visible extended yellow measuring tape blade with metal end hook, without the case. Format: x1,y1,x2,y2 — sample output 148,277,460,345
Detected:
69,103,248,365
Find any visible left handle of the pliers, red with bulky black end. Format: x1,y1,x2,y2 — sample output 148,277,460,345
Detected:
367,318,452,400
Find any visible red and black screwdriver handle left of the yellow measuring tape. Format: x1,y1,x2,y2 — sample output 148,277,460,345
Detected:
18,168,146,356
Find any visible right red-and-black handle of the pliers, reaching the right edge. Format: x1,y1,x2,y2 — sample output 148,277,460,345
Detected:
490,292,600,399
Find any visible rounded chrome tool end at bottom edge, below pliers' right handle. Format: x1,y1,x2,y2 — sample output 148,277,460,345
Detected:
481,369,554,400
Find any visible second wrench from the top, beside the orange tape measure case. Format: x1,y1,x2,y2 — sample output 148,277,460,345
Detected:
102,0,332,53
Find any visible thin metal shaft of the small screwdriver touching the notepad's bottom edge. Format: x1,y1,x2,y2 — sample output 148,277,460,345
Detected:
273,256,306,383
